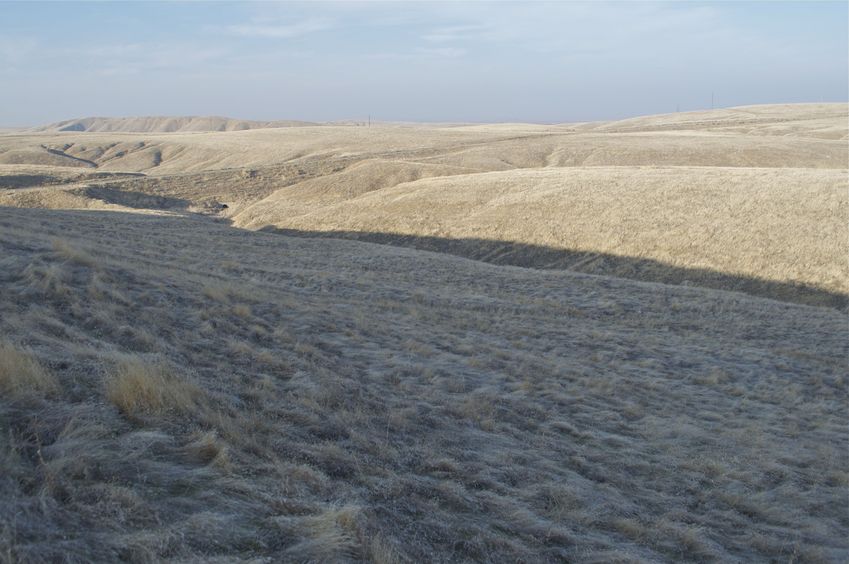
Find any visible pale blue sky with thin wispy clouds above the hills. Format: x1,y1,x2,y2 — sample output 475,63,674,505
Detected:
0,1,849,126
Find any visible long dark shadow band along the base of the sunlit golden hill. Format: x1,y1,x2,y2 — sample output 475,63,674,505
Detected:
261,227,849,311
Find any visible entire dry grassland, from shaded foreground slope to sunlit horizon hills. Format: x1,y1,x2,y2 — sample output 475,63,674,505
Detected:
0,105,849,562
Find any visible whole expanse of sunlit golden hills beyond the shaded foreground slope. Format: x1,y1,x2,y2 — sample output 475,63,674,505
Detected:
0,104,849,308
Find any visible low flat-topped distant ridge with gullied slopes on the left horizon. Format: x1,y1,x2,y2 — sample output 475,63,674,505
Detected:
30,116,316,133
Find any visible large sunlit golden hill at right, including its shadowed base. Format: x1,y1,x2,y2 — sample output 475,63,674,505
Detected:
233,167,849,307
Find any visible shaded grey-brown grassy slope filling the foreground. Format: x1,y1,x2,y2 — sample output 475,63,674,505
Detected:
0,205,849,562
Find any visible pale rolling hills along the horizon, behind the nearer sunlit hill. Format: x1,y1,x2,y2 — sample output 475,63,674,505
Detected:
0,104,849,175
